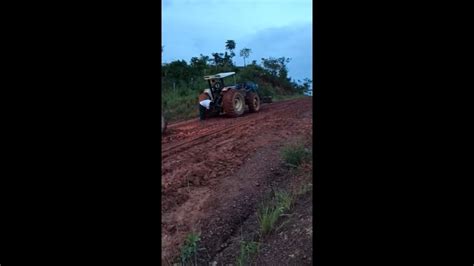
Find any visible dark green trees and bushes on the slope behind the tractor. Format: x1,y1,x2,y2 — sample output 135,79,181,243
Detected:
161,40,311,119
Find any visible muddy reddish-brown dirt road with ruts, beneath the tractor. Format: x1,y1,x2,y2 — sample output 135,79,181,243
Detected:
161,97,312,263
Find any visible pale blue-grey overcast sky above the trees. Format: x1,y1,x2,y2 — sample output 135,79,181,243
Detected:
161,0,312,83
